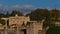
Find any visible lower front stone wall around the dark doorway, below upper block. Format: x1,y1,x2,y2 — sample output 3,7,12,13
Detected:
2,22,43,34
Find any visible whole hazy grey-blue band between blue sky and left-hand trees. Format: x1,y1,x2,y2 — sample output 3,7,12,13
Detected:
0,4,37,14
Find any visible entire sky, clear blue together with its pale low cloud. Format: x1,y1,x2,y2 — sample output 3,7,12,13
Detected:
0,0,60,13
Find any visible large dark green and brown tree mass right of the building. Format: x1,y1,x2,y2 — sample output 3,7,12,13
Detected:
27,9,60,27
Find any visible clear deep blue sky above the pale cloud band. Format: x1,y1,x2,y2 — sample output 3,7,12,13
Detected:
0,0,60,8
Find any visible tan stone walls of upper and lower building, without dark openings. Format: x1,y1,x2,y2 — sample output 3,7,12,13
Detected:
0,15,44,34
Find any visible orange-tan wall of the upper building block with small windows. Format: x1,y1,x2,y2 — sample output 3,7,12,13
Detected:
9,16,30,25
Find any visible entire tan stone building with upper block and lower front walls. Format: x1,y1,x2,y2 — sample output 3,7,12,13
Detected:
0,14,45,34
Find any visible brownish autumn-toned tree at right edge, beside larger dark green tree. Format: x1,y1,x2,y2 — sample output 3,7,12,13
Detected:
43,9,60,27
